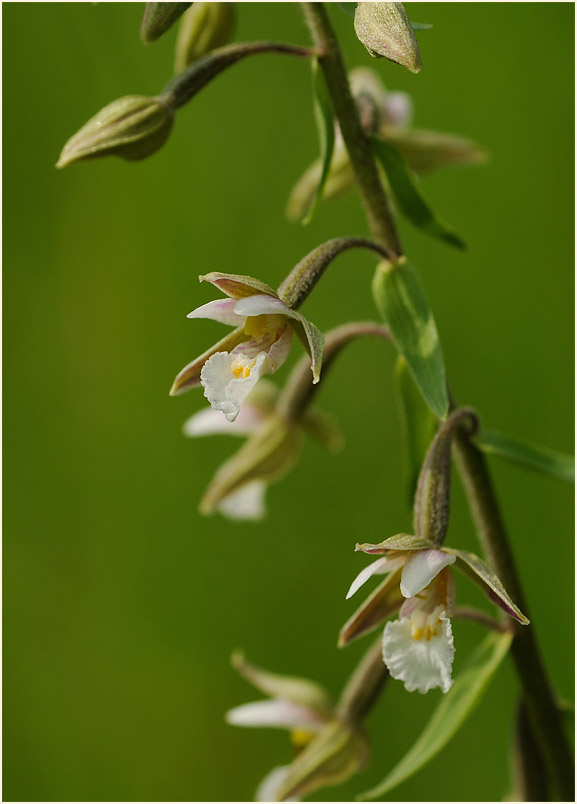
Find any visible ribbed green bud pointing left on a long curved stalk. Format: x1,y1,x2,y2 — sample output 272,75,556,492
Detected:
56,95,173,167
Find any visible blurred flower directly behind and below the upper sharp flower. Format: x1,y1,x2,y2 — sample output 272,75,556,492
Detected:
183,379,343,520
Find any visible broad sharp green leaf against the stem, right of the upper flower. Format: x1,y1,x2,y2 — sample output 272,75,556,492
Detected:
373,258,449,419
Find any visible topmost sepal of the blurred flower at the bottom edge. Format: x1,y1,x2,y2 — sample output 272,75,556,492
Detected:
230,651,335,716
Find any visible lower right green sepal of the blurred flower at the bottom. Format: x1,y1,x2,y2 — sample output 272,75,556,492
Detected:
276,720,368,801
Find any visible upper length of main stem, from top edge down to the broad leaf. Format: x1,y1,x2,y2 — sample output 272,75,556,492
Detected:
302,3,403,258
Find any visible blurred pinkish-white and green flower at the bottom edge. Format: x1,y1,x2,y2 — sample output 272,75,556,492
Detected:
226,654,368,801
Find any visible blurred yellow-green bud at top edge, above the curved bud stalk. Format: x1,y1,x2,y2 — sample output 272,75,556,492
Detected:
174,3,234,73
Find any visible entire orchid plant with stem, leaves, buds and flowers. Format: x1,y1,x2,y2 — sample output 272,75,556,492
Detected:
58,3,573,801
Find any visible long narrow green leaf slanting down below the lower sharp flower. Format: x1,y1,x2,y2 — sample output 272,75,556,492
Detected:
358,633,512,801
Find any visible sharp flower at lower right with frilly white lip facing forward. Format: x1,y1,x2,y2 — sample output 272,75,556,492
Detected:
347,534,529,693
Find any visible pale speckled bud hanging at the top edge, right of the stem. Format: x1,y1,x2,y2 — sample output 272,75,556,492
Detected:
355,3,422,73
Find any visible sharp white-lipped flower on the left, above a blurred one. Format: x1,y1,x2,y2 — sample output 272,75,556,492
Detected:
170,271,323,422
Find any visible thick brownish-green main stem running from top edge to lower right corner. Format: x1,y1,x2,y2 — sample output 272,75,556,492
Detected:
302,3,574,801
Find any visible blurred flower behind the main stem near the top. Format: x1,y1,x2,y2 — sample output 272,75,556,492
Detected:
286,67,486,221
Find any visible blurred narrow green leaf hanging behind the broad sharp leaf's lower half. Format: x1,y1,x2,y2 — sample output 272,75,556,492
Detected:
395,355,436,510
